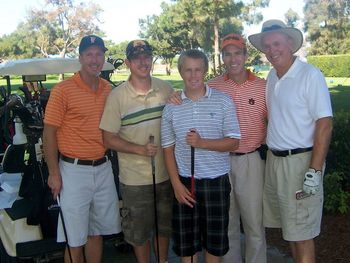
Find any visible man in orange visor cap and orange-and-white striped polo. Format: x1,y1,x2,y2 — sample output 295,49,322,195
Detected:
208,34,267,263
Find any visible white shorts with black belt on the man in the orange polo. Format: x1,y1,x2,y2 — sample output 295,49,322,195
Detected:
57,160,121,247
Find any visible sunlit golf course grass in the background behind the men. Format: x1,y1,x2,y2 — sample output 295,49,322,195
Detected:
0,72,350,112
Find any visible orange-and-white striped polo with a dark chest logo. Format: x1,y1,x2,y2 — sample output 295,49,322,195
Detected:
208,70,267,153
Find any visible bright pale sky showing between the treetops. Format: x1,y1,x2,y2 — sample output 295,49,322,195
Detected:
0,0,304,43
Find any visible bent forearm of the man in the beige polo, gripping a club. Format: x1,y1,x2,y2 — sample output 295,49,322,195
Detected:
103,131,158,156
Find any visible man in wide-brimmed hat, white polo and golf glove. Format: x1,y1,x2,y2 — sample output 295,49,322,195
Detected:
248,20,332,263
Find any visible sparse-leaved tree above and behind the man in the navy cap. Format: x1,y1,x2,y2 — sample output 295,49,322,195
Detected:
26,0,102,57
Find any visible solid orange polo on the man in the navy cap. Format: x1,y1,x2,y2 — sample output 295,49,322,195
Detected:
44,73,111,160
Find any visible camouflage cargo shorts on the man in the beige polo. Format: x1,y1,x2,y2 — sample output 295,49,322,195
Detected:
120,180,174,246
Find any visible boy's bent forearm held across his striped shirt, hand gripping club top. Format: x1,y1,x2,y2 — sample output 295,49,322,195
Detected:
186,130,239,152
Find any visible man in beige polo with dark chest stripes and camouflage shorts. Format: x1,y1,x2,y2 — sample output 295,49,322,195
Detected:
100,39,173,263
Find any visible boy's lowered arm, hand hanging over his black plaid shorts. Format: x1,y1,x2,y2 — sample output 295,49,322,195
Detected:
163,145,196,207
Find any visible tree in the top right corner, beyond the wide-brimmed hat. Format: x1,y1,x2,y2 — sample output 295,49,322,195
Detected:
304,0,350,55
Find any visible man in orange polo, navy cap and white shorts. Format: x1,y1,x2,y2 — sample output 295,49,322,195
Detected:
44,35,121,263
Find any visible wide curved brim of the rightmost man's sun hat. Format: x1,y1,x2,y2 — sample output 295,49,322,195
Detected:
248,28,303,54
